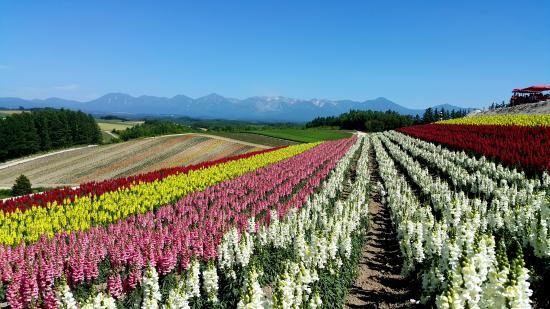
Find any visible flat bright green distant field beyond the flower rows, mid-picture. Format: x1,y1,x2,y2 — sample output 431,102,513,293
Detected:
250,128,351,143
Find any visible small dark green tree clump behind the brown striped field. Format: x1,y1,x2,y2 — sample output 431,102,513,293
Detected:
113,120,193,141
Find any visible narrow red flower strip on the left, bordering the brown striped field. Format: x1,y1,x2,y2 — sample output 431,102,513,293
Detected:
0,147,284,213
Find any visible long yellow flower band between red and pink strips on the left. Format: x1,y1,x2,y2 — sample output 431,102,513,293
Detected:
0,143,319,245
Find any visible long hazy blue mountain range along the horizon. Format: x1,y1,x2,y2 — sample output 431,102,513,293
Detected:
0,93,472,122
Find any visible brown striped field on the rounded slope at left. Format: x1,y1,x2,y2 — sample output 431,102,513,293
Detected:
0,134,261,187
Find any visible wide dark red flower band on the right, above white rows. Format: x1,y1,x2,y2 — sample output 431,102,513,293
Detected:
398,124,550,171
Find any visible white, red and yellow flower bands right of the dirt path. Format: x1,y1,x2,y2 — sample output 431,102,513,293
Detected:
394,115,550,308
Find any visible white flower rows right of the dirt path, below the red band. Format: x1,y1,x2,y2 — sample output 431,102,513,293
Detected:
373,127,550,308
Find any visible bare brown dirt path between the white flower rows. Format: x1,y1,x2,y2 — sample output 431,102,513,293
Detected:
345,148,421,308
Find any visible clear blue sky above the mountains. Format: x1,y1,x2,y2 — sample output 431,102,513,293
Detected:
0,0,550,108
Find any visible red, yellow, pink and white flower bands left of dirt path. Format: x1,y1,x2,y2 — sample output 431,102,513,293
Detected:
0,137,380,308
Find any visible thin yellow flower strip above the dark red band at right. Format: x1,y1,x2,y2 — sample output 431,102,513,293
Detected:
436,114,550,127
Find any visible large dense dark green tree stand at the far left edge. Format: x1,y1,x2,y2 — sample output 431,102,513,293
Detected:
0,108,101,162
